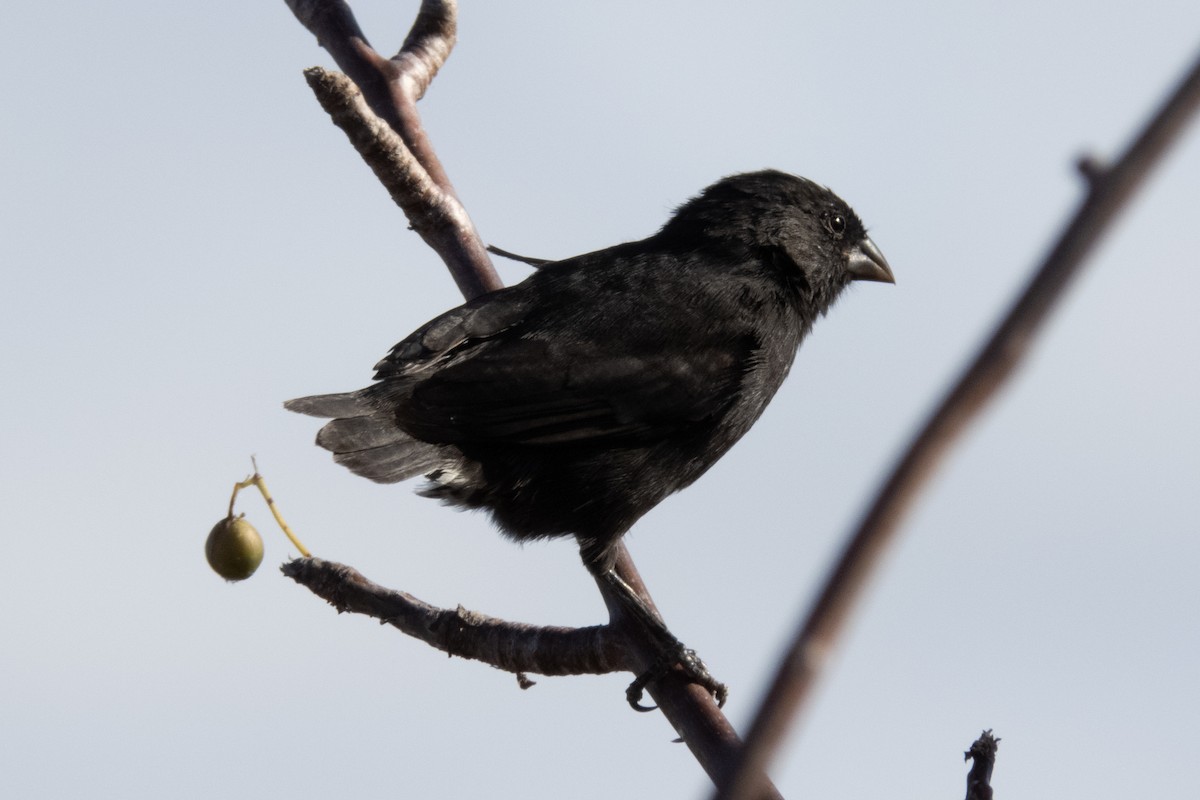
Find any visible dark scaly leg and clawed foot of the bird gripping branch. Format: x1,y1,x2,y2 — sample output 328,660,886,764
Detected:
582,546,728,711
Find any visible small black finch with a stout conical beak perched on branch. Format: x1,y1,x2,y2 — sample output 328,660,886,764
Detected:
287,170,893,705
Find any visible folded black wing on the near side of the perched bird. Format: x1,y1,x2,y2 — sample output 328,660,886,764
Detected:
372,284,756,445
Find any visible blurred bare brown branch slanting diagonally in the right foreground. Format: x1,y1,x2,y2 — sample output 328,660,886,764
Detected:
716,48,1200,800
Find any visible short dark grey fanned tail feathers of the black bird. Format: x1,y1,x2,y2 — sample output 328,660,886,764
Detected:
283,390,457,483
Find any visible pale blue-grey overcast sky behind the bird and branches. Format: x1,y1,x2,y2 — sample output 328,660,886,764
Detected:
0,0,1200,800
